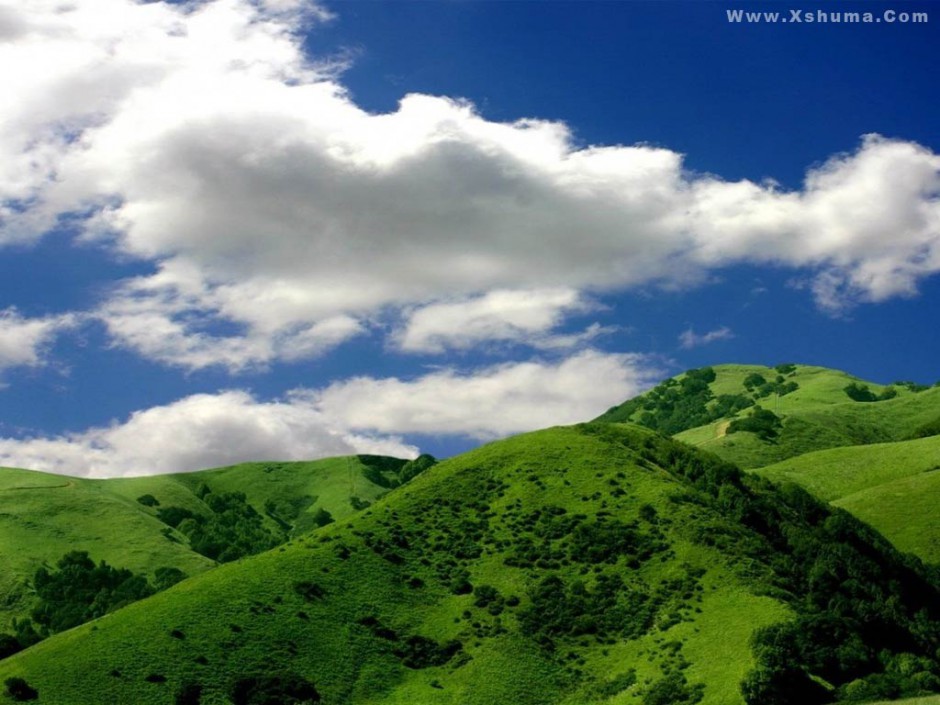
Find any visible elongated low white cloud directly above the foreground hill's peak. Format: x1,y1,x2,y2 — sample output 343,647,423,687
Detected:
304,350,660,439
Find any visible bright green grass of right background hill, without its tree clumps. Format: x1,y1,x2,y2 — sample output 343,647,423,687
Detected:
602,365,940,563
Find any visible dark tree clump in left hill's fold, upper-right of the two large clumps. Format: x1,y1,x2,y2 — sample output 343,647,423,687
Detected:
157,484,284,563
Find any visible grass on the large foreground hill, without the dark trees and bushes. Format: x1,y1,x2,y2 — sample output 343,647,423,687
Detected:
0,425,936,705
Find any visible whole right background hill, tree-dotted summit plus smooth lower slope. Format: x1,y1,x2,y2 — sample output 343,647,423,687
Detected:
599,365,940,563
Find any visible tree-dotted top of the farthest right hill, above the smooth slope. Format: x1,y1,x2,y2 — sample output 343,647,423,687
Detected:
598,365,940,468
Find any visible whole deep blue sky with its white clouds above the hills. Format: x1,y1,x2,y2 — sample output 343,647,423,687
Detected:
0,0,940,476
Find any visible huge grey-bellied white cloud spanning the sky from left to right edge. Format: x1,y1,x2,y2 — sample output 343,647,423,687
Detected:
0,0,940,370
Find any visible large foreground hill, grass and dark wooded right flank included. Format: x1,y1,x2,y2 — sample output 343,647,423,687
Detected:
0,424,940,705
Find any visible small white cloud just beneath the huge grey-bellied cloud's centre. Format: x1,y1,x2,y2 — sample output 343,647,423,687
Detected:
396,289,600,353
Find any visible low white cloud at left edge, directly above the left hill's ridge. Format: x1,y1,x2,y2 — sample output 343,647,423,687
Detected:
0,391,417,477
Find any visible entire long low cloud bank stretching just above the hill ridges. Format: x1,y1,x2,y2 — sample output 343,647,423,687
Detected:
0,350,660,477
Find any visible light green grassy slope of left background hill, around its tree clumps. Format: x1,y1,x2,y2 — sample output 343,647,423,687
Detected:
0,457,406,632
